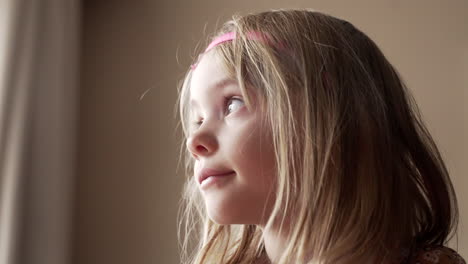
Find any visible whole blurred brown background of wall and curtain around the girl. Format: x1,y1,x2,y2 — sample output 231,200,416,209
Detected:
0,0,468,264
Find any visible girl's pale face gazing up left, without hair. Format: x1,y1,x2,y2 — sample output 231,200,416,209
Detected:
187,52,276,225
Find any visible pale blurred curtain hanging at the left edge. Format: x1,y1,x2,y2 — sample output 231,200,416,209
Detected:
0,0,80,264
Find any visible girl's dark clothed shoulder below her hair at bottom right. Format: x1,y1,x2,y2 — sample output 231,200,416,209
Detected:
408,246,466,264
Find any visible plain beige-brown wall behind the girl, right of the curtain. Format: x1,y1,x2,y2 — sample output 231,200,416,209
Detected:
74,0,468,264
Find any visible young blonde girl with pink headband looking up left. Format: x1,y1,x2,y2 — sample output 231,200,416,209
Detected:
179,10,464,264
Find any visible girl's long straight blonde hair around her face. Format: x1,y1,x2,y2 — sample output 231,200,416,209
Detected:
175,9,458,263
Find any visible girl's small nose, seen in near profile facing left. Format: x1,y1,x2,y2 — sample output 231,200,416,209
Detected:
187,131,218,160
